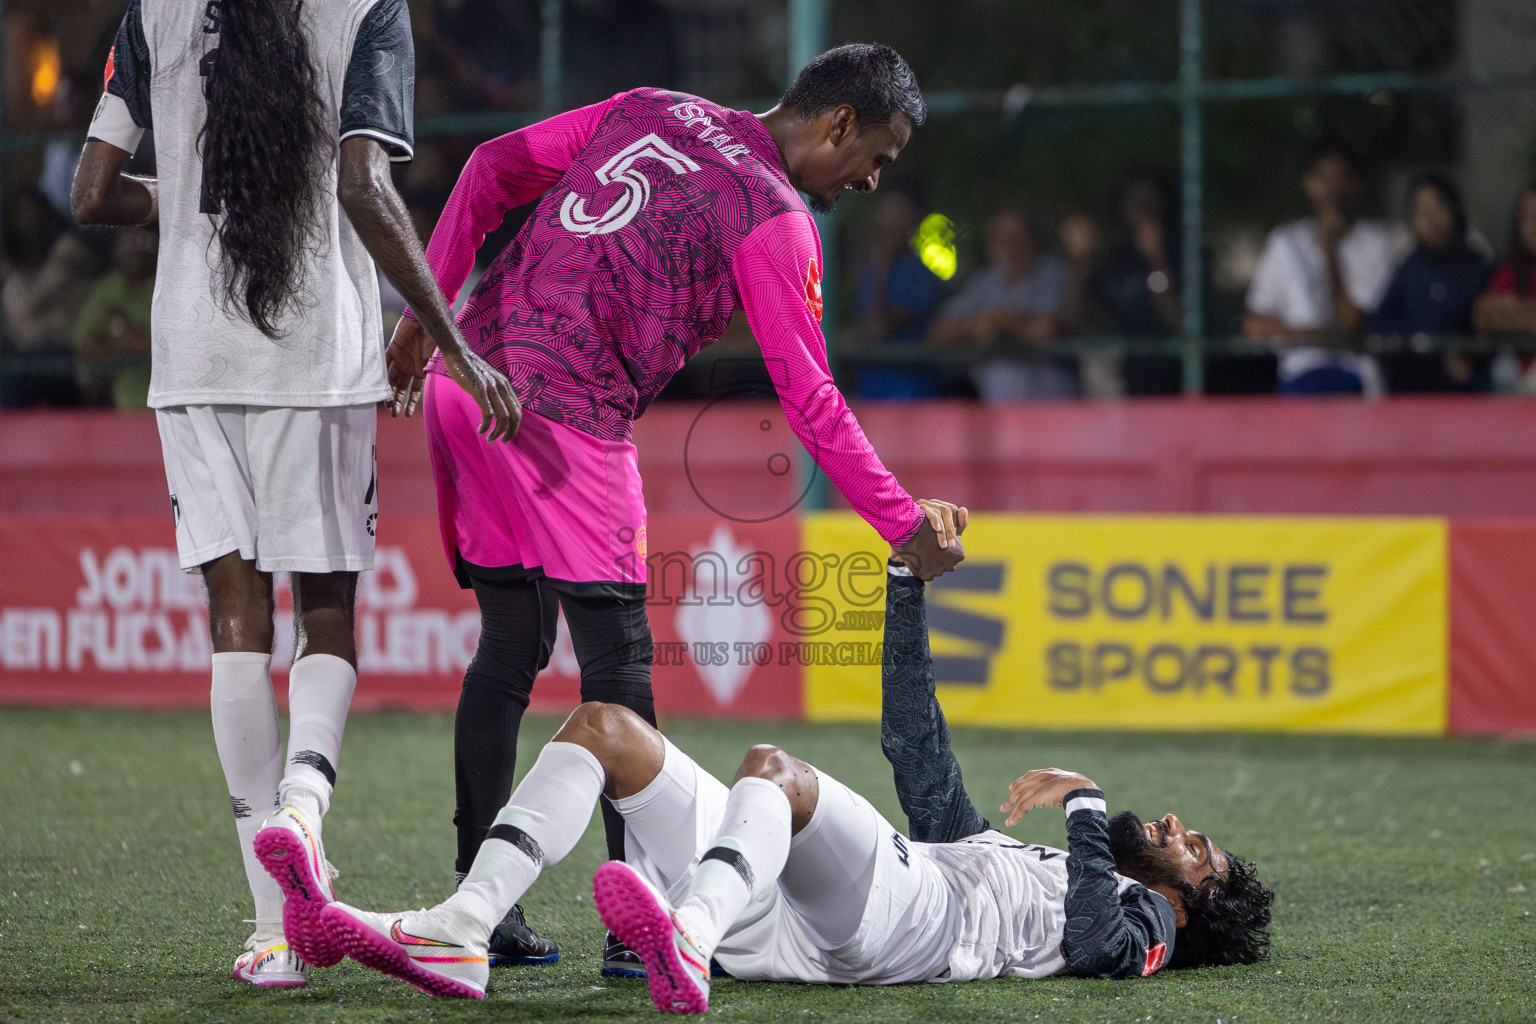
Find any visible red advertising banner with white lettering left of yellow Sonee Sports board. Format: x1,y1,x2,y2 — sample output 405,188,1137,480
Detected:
0,516,802,718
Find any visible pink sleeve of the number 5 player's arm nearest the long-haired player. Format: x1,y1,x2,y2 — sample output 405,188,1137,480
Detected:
406,94,624,316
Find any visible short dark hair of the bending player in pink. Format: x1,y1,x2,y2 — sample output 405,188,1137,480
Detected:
779,43,928,127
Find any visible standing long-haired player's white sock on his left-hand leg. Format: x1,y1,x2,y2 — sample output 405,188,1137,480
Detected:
209,651,283,933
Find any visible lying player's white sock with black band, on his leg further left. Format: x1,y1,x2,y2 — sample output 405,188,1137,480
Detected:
444,742,604,936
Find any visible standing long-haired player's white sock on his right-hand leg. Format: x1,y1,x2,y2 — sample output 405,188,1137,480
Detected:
278,654,358,826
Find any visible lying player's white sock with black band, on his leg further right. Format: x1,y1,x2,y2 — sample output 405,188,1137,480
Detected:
677,777,790,955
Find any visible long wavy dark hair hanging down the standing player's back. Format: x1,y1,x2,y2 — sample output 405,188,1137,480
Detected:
198,0,326,338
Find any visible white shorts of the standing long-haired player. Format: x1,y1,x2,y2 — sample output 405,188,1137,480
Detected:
155,404,378,573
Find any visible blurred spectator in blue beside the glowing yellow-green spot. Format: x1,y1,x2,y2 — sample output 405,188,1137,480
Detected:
854,184,943,398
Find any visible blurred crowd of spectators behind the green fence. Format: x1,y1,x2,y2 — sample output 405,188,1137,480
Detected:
9,101,1536,410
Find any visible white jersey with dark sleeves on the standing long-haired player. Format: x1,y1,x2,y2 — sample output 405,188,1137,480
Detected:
91,0,415,408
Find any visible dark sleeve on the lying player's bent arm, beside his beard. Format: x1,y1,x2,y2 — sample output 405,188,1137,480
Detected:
1061,789,1174,978
